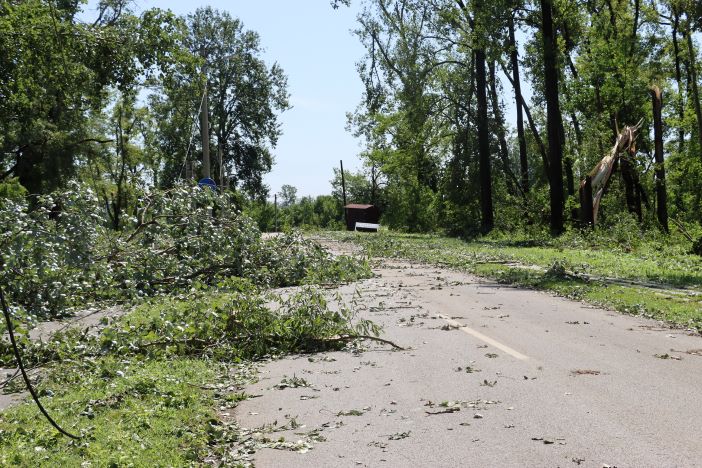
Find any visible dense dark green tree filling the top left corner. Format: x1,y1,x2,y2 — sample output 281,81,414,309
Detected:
0,0,184,193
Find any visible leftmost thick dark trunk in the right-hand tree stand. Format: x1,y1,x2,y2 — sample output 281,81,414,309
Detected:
475,45,494,233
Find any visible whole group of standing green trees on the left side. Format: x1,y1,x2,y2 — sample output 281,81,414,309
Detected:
0,0,288,207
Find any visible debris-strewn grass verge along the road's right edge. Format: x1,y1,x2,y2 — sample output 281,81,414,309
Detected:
324,231,702,331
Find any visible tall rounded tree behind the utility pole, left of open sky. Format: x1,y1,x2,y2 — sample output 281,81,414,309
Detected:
157,7,289,198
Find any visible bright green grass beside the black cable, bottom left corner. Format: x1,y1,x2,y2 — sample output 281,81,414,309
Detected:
0,357,218,467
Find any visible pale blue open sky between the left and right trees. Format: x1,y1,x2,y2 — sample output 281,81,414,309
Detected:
102,0,364,197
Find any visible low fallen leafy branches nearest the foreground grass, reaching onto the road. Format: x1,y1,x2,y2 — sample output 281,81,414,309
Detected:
0,280,379,365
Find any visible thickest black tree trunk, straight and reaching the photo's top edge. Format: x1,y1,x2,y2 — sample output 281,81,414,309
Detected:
541,0,564,235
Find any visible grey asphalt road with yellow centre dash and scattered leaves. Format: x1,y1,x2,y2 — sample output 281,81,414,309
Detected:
232,249,702,468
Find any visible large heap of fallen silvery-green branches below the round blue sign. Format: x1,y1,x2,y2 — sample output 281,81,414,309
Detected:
0,184,369,318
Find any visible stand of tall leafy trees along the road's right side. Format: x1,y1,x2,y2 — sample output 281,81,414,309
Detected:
340,0,702,233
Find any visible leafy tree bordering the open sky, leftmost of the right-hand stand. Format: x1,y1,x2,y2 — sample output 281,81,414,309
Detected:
353,0,444,230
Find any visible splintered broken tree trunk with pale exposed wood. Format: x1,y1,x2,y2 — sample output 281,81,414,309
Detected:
580,120,643,226
